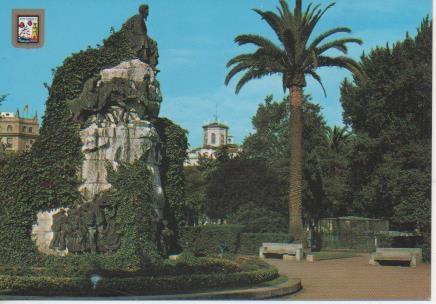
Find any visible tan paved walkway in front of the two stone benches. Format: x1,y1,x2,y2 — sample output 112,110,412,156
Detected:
267,254,431,300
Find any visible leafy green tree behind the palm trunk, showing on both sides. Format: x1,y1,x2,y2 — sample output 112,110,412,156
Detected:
243,96,328,226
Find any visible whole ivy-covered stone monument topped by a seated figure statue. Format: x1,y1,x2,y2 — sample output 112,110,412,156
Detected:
0,5,187,269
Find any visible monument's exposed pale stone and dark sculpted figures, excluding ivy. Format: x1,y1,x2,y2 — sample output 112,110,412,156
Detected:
34,5,172,254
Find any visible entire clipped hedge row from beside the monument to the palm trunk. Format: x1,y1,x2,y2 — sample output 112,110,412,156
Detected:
179,225,294,256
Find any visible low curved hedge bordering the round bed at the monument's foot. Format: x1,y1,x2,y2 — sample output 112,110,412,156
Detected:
0,259,279,296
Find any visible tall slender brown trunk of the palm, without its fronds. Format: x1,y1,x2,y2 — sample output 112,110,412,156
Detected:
289,85,305,243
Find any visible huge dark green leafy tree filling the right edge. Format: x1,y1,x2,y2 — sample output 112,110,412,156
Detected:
341,17,432,256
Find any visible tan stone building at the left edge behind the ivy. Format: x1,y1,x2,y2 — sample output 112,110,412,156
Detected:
0,111,39,152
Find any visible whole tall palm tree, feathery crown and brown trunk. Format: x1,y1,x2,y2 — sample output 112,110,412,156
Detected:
225,0,362,243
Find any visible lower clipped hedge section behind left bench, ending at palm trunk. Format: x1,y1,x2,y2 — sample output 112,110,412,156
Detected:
238,233,294,255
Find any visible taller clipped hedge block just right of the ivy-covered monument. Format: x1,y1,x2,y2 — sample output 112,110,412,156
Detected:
179,225,243,256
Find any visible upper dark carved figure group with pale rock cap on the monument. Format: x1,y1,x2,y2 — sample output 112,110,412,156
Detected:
67,59,162,125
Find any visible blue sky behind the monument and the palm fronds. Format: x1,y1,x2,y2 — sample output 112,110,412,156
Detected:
0,0,432,146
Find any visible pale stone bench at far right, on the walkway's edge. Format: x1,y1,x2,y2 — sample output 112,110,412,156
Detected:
369,248,422,268
